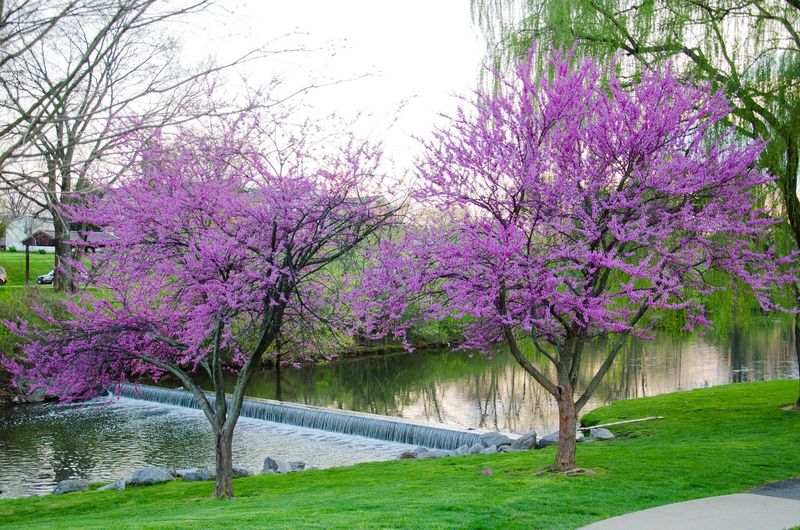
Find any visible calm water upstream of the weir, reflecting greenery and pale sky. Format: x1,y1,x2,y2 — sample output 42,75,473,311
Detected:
231,320,797,433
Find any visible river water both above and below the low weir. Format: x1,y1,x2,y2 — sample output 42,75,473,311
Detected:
0,320,798,497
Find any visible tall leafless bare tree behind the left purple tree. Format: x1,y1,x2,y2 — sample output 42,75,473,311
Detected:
0,0,282,289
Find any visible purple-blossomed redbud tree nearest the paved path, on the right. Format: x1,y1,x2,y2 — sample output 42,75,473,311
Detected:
354,54,793,471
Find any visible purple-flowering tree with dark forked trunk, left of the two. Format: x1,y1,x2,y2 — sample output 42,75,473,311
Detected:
6,111,391,497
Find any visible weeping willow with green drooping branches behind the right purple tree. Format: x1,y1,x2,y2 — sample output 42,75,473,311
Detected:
472,0,800,407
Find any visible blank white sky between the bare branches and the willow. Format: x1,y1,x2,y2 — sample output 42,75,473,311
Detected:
182,0,485,176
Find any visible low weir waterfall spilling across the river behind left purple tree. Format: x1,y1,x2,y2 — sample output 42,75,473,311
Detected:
117,385,481,450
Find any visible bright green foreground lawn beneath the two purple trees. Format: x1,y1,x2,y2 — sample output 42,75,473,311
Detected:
0,381,800,529
